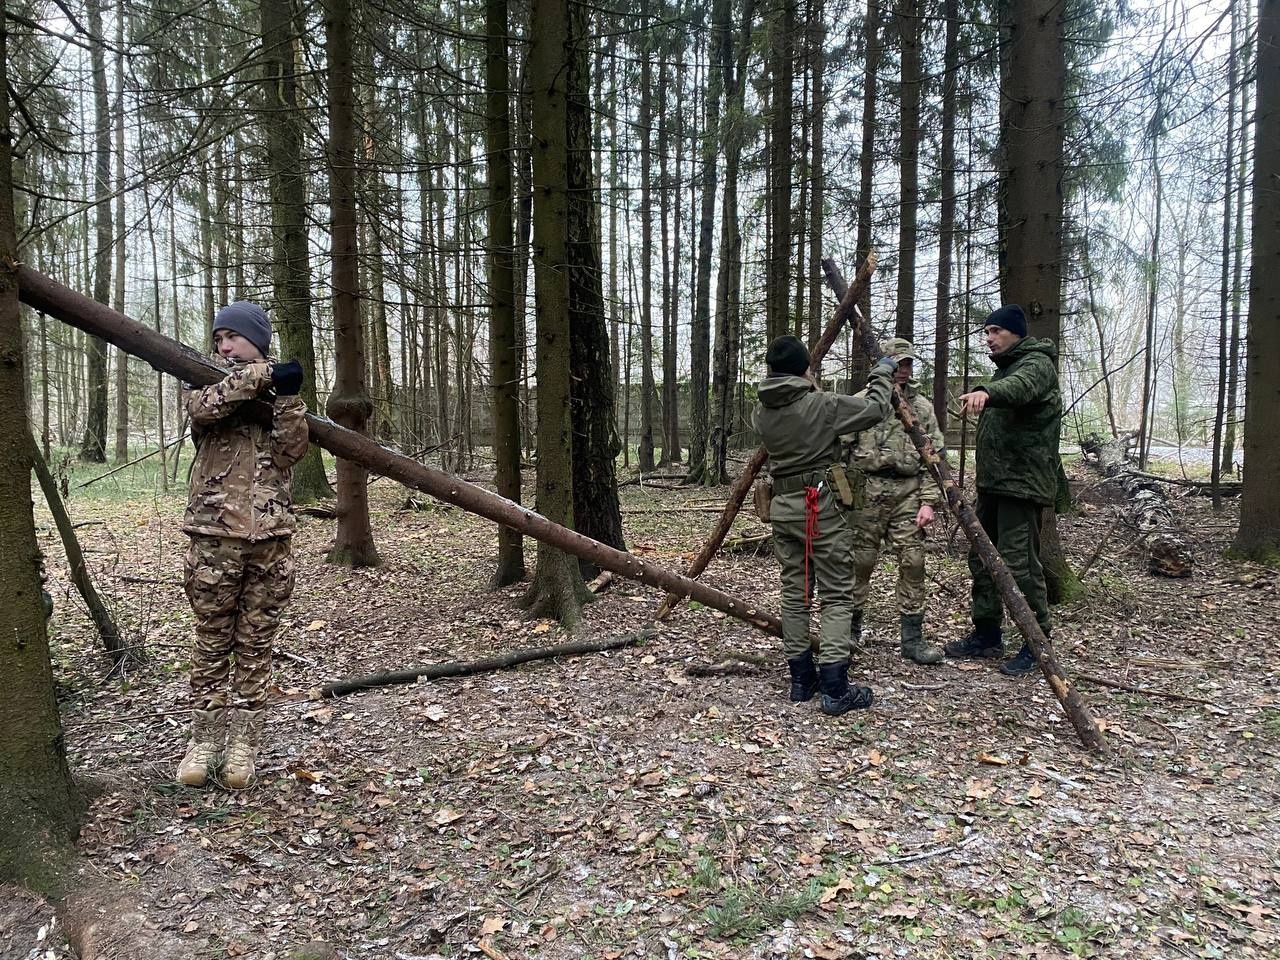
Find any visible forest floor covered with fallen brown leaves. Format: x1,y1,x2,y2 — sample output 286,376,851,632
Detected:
0,453,1280,960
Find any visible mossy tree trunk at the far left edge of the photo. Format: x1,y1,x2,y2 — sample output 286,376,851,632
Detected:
0,18,82,891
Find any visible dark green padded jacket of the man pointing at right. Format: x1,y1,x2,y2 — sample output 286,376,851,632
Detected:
975,337,1064,506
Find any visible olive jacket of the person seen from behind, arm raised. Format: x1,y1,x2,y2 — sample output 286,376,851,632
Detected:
751,369,892,520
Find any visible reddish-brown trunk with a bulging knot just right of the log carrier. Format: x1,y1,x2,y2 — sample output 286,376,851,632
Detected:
325,0,378,567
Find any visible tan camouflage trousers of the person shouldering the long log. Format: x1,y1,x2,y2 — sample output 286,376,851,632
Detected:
183,536,293,710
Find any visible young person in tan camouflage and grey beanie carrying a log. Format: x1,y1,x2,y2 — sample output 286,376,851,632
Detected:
178,301,307,788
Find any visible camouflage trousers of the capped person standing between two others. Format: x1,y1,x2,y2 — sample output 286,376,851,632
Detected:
849,476,924,616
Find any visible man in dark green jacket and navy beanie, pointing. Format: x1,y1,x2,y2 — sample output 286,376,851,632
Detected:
946,303,1062,677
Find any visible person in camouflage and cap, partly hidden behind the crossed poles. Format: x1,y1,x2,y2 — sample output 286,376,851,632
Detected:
847,338,943,664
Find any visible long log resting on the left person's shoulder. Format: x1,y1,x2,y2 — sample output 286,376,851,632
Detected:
18,265,782,636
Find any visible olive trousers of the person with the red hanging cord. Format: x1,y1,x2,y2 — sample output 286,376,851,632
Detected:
773,508,854,664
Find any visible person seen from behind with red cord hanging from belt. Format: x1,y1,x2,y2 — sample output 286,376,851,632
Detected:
751,337,897,716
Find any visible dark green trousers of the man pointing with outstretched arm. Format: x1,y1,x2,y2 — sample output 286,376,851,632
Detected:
969,490,1052,636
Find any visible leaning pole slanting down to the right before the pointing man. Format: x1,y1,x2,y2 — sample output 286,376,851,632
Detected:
822,257,1107,753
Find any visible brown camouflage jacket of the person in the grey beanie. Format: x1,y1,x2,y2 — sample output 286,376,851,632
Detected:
182,361,308,541
